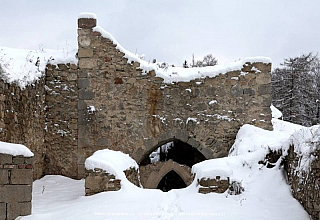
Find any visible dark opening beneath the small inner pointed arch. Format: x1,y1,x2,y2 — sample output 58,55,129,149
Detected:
157,170,187,192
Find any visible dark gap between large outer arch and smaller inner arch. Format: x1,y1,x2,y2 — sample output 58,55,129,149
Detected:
140,139,206,167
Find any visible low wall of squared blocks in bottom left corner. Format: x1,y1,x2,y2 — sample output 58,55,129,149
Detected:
0,154,33,220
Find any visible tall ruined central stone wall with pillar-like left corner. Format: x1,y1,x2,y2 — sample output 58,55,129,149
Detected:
78,15,272,177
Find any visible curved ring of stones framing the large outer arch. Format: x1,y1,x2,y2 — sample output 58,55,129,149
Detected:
133,130,213,164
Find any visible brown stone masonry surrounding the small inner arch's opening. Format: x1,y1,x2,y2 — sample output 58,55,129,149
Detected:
139,160,194,189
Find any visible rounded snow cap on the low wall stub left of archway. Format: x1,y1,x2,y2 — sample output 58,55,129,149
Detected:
85,149,139,179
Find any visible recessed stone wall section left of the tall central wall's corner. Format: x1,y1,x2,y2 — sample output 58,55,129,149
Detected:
44,64,79,178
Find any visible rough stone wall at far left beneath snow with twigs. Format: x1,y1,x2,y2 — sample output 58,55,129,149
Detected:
0,78,46,179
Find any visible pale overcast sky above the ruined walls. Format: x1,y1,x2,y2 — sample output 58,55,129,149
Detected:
0,0,320,66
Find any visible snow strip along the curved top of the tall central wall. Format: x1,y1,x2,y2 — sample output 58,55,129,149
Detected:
93,17,272,83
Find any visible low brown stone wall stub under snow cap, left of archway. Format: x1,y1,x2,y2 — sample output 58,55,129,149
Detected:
85,169,121,196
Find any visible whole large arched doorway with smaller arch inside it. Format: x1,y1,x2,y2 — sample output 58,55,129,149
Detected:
140,139,207,192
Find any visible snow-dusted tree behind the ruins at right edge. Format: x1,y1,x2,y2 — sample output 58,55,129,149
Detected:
272,53,320,126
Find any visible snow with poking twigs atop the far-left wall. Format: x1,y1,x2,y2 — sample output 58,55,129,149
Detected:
0,47,78,89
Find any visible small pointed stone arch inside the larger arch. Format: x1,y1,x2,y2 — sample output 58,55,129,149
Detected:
144,160,193,189
